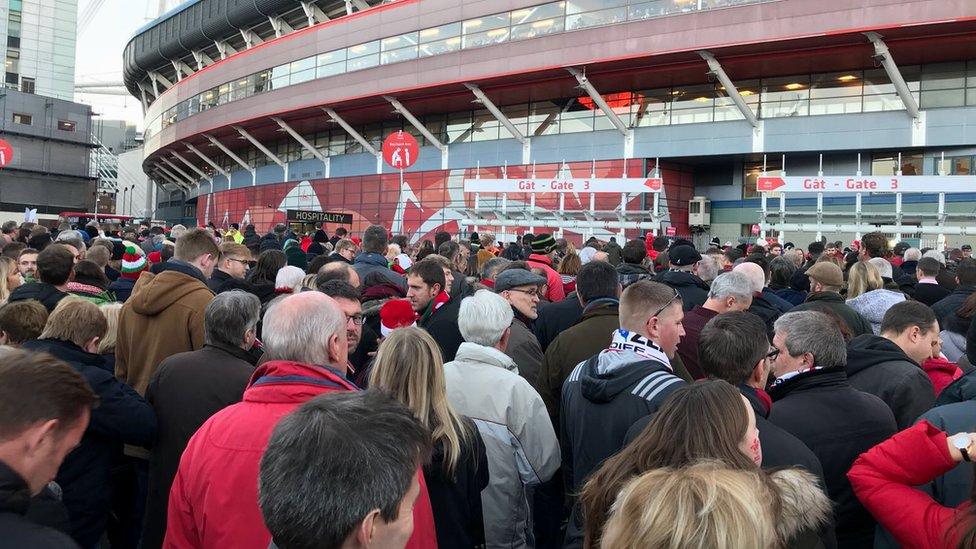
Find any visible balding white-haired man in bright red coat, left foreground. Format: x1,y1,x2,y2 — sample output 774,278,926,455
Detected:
163,292,437,549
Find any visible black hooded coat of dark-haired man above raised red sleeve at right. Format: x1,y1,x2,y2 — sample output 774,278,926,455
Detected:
847,335,935,429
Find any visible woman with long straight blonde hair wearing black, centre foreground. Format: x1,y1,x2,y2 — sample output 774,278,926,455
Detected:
369,328,488,548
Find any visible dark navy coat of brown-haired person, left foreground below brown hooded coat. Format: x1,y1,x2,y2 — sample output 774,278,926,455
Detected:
23,339,156,547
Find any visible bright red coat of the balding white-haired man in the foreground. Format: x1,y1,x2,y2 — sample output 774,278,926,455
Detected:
164,360,436,549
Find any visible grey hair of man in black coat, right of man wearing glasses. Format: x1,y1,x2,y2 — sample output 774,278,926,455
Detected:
774,311,847,368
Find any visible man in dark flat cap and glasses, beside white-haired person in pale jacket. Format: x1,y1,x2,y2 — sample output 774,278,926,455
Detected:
495,263,546,387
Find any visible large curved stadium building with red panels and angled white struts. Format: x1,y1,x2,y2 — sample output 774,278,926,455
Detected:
124,0,976,244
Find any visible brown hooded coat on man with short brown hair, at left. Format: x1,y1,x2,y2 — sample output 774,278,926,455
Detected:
115,261,213,394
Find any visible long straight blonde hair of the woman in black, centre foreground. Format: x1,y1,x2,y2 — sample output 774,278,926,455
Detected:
369,327,472,478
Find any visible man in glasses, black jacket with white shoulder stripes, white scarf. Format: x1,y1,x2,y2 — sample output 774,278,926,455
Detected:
559,280,686,547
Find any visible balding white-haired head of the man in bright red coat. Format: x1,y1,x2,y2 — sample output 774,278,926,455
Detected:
261,292,346,364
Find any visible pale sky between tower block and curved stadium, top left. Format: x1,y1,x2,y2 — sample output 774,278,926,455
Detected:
75,0,179,129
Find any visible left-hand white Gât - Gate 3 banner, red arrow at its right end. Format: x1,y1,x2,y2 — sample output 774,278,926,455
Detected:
464,177,664,193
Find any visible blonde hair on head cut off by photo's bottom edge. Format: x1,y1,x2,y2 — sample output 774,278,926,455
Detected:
600,461,782,549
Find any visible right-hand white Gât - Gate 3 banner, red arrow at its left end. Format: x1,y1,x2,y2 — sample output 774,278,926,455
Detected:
756,175,976,193
